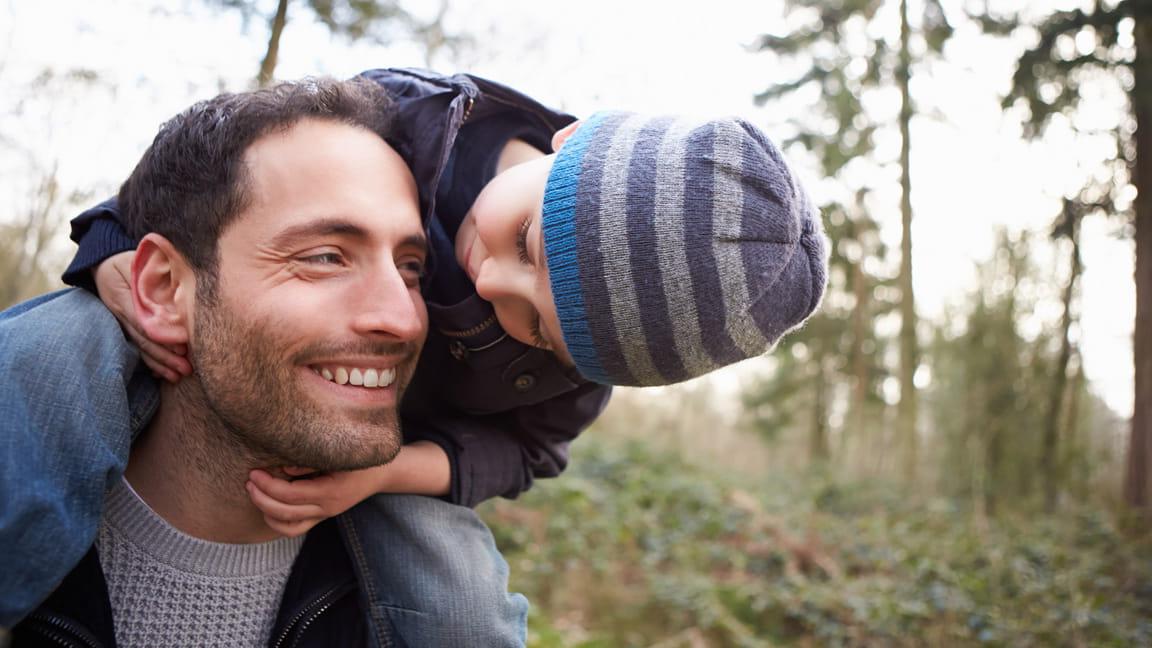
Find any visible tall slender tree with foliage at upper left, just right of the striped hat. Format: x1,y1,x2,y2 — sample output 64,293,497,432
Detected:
757,0,952,480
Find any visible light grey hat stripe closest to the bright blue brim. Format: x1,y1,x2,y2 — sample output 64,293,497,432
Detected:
600,115,659,383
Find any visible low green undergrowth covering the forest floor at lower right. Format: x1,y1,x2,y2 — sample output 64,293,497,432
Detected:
483,432,1152,648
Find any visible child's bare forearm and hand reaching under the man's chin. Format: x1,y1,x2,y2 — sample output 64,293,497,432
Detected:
247,442,452,537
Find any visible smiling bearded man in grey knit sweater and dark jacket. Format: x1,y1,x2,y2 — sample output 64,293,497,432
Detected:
6,76,499,646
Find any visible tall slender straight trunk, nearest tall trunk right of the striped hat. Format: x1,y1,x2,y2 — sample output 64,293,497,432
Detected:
896,0,919,481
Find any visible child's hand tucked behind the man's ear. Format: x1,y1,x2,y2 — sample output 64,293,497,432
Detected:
92,251,192,383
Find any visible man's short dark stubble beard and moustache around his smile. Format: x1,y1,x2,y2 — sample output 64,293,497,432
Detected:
182,290,419,472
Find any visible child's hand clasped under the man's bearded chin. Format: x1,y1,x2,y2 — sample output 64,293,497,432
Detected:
247,466,385,537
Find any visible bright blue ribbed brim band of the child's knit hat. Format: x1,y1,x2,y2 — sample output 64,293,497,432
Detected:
541,108,611,383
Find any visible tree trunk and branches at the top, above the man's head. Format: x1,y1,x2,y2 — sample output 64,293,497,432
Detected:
209,0,468,88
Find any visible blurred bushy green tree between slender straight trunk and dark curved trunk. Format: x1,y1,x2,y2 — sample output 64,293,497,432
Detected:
925,232,1054,515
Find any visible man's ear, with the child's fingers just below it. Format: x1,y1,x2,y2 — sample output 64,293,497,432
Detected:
132,234,196,345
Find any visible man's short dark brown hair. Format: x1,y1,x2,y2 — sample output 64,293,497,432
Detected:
119,77,395,296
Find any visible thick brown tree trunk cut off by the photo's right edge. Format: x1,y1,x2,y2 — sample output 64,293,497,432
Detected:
1124,8,1152,518
